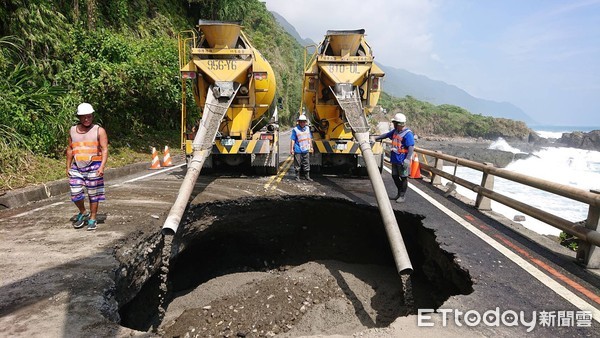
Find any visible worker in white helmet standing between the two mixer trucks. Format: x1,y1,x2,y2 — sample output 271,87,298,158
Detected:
290,114,313,181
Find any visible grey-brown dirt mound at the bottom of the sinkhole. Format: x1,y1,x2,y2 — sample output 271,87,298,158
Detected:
163,261,409,337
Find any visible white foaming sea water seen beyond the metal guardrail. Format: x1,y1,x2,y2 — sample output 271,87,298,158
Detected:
442,127,600,236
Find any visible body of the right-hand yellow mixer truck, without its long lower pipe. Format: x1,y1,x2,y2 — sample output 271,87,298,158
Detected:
302,29,385,174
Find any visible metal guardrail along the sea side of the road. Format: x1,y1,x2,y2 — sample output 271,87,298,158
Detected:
382,140,600,269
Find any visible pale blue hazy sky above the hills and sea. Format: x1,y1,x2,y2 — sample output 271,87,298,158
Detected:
266,0,600,129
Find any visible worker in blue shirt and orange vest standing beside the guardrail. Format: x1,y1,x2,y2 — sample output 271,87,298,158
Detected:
375,113,415,203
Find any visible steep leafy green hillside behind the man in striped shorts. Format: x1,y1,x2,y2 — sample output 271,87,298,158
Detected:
0,0,303,191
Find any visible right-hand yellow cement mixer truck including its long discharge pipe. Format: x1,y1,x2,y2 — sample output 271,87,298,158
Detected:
302,29,412,275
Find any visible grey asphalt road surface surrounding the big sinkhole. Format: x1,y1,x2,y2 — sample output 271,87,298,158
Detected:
0,133,600,337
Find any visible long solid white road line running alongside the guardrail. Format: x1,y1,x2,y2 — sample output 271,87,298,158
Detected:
384,167,600,323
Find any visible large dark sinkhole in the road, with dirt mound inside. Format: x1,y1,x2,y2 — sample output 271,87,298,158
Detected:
116,196,473,336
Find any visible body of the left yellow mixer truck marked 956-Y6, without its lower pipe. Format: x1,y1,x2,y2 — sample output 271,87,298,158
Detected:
179,20,279,174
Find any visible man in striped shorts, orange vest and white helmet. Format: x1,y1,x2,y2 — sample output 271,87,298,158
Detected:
67,103,108,230
